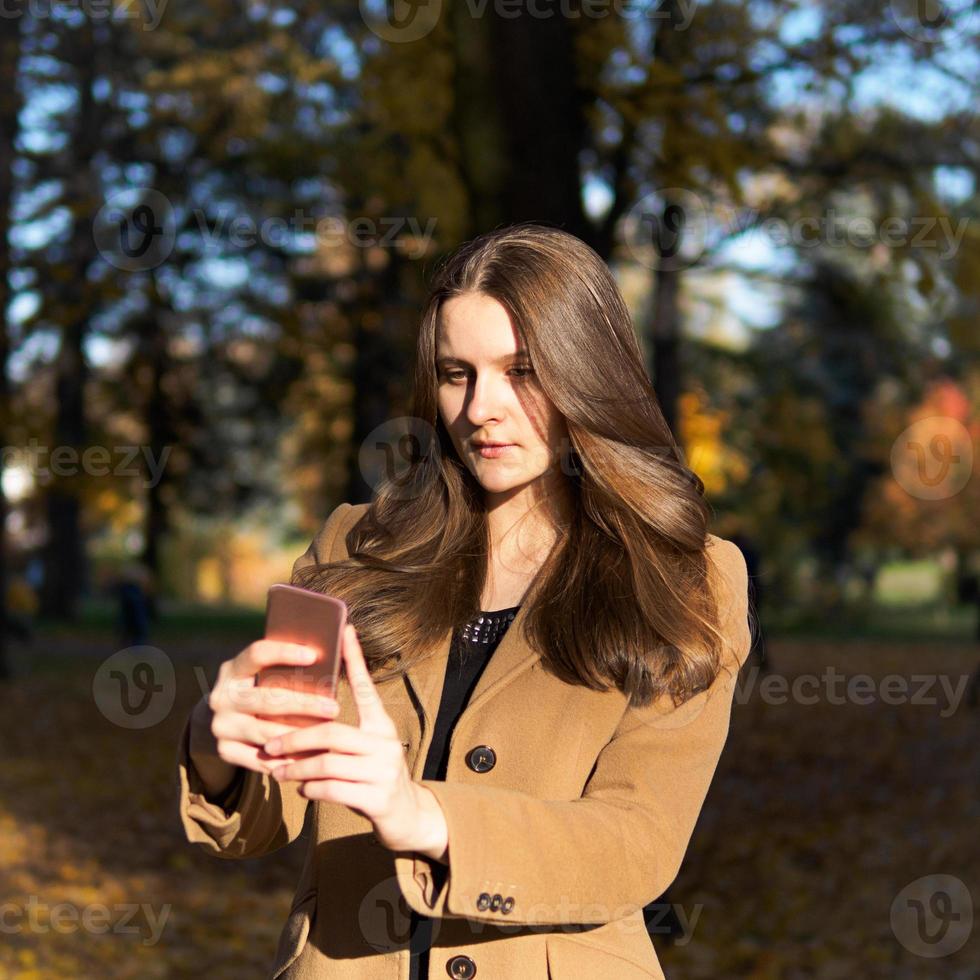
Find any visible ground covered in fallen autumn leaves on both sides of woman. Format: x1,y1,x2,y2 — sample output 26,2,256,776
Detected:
0,639,980,980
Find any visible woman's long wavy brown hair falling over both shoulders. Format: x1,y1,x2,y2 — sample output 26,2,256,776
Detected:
294,223,752,706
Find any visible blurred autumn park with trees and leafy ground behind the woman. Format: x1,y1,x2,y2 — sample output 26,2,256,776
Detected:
0,0,980,980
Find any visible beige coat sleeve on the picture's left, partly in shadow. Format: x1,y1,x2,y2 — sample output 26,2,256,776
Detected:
177,503,350,858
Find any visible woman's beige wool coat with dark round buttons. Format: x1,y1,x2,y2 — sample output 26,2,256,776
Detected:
177,504,750,980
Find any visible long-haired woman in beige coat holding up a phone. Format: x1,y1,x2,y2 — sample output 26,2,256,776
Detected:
178,225,750,980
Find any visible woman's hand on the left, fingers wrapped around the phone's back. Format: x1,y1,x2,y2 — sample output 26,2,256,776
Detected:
207,639,339,773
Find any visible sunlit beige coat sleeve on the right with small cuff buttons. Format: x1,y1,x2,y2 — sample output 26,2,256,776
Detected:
394,536,751,925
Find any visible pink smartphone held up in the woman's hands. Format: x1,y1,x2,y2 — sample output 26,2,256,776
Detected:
255,584,347,728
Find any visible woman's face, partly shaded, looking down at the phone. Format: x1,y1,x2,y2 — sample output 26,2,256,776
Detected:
436,293,568,494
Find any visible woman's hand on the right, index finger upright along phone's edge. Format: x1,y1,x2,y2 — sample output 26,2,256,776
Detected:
265,623,447,858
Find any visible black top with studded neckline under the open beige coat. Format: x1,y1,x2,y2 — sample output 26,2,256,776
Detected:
408,606,520,980
